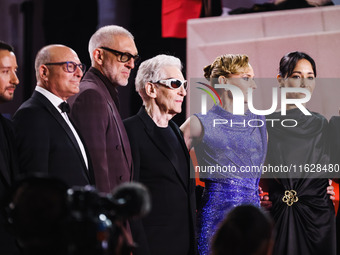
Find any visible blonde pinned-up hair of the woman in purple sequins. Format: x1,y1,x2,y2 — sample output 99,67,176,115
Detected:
203,54,249,83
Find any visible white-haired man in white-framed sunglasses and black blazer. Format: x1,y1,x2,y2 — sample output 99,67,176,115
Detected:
124,55,196,255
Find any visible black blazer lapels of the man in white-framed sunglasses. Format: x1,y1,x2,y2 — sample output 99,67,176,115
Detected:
137,107,189,190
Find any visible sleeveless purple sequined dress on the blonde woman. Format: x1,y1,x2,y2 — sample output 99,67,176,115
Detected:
195,105,267,255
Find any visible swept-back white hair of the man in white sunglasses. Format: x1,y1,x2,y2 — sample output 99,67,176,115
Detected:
135,54,182,101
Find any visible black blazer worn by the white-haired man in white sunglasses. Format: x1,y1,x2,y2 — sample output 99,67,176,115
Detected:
124,108,196,255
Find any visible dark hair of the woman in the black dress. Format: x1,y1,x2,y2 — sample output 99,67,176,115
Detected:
279,51,316,78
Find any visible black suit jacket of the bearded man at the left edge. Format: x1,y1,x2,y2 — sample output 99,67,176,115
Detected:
0,114,19,254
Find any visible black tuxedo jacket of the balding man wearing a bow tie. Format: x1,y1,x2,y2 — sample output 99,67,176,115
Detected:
13,91,94,186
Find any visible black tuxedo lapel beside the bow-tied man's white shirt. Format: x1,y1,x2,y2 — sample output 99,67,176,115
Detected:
32,91,90,180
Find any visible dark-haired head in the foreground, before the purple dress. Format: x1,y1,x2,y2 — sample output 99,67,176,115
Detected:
211,205,273,255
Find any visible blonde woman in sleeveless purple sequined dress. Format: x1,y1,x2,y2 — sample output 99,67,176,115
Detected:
181,54,267,255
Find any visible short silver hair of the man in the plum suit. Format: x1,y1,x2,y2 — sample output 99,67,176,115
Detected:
89,25,134,64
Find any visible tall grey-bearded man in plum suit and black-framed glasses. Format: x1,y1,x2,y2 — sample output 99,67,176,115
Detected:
69,26,138,193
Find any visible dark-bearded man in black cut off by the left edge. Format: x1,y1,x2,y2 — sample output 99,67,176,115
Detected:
0,41,19,255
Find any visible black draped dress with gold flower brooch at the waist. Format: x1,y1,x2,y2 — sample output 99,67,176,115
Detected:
267,109,336,255
